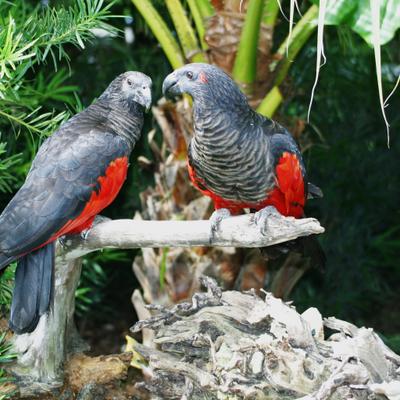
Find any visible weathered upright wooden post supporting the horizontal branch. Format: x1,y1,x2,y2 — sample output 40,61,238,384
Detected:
12,258,82,397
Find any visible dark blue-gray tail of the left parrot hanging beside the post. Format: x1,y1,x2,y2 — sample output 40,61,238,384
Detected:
9,242,55,334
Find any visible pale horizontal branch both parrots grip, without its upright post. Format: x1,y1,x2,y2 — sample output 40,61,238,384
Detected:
57,207,324,261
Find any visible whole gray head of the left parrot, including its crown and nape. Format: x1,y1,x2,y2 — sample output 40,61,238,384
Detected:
103,71,152,111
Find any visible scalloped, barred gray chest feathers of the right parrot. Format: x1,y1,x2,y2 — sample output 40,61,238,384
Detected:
188,118,276,204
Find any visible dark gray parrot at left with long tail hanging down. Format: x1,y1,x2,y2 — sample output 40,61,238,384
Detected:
0,72,152,333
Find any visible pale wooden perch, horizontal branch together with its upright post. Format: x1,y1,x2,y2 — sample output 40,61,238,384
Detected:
7,209,324,396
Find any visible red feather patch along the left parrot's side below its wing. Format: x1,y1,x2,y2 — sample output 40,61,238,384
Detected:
46,157,128,243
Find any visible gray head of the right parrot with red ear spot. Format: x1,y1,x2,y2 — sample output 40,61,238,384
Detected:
162,63,247,104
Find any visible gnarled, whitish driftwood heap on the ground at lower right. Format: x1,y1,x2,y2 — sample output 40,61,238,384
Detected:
132,278,400,400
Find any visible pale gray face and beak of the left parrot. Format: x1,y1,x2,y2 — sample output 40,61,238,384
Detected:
121,71,152,110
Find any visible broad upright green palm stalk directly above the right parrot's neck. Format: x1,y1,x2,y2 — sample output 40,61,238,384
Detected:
232,0,264,91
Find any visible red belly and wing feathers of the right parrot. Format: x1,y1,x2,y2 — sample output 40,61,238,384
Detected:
188,152,305,218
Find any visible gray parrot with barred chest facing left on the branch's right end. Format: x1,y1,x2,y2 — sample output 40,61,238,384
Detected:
163,63,324,258
